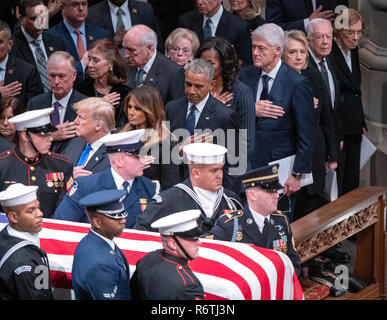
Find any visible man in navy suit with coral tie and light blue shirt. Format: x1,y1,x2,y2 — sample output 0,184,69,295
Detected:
46,0,113,82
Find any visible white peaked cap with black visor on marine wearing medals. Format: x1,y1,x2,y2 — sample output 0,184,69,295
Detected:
9,107,58,133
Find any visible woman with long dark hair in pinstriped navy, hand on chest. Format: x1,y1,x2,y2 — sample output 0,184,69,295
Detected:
196,37,255,168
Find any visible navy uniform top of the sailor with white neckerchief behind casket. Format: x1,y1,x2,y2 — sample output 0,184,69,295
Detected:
134,179,242,233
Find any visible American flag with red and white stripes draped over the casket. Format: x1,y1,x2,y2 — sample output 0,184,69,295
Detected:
0,214,304,300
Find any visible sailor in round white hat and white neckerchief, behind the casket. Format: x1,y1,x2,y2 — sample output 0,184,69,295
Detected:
134,143,242,233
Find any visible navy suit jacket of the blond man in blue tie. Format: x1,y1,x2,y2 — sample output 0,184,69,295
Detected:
63,137,110,173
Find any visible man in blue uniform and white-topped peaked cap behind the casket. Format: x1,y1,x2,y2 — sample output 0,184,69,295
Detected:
54,129,156,228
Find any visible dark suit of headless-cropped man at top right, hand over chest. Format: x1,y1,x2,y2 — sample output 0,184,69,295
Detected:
266,0,348,32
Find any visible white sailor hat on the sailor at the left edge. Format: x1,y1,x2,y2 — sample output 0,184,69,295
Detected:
0,183,38,207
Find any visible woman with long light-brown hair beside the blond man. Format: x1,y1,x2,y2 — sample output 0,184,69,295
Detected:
120,85,180,190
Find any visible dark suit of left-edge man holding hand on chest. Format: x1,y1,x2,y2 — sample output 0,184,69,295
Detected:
4,54,43,105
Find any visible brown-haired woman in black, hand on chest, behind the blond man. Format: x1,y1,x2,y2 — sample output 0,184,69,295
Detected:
76,39,129,128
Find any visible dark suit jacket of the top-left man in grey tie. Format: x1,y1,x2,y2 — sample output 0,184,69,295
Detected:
11,27,66,88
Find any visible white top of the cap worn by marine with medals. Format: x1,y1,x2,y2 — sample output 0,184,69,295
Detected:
9,107,54,131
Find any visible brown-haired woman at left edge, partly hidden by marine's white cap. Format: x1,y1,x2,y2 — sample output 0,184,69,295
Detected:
0,97,26,152
